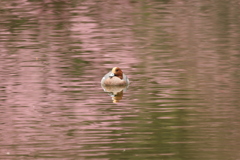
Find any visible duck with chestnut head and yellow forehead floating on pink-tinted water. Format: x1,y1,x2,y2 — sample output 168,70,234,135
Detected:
101,67,130,86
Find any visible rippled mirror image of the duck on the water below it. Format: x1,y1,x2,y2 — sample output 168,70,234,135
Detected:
102,85,128,103
